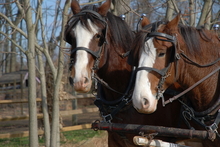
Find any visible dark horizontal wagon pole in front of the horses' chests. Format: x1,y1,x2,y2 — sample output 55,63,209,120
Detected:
92,122,216,140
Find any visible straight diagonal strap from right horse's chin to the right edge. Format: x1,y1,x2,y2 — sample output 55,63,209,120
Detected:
164,67,220,105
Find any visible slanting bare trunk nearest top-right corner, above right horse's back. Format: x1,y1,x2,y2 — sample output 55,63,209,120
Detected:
197,0,212,29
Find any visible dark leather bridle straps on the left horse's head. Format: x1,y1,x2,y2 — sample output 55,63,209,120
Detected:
67,10,108,71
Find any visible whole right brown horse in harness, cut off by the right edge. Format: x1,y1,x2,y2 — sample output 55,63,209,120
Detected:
130,14,220,147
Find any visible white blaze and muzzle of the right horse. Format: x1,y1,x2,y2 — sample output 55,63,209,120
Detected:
132,38,157,113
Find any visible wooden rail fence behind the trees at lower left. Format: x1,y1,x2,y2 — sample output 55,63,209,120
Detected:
0,94,98,138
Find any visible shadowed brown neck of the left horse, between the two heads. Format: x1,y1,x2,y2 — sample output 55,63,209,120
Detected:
97,48,131,100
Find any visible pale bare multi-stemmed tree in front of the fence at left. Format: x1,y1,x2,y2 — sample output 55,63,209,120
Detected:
0,0,70,147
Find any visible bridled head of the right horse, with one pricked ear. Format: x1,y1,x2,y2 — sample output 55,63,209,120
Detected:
131,15,180,113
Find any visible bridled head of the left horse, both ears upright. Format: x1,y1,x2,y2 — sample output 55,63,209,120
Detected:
65,0,111,92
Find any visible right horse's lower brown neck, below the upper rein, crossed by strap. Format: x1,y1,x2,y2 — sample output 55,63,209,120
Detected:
179,59,220,111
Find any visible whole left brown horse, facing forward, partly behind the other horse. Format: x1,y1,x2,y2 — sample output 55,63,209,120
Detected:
65,0,184,147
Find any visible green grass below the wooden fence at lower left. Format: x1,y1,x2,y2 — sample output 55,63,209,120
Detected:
0,129,103,147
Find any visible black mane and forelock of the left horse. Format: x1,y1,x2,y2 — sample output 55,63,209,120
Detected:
65,5,134,51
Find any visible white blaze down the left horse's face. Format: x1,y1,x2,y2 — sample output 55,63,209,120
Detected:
74,20,98,83
